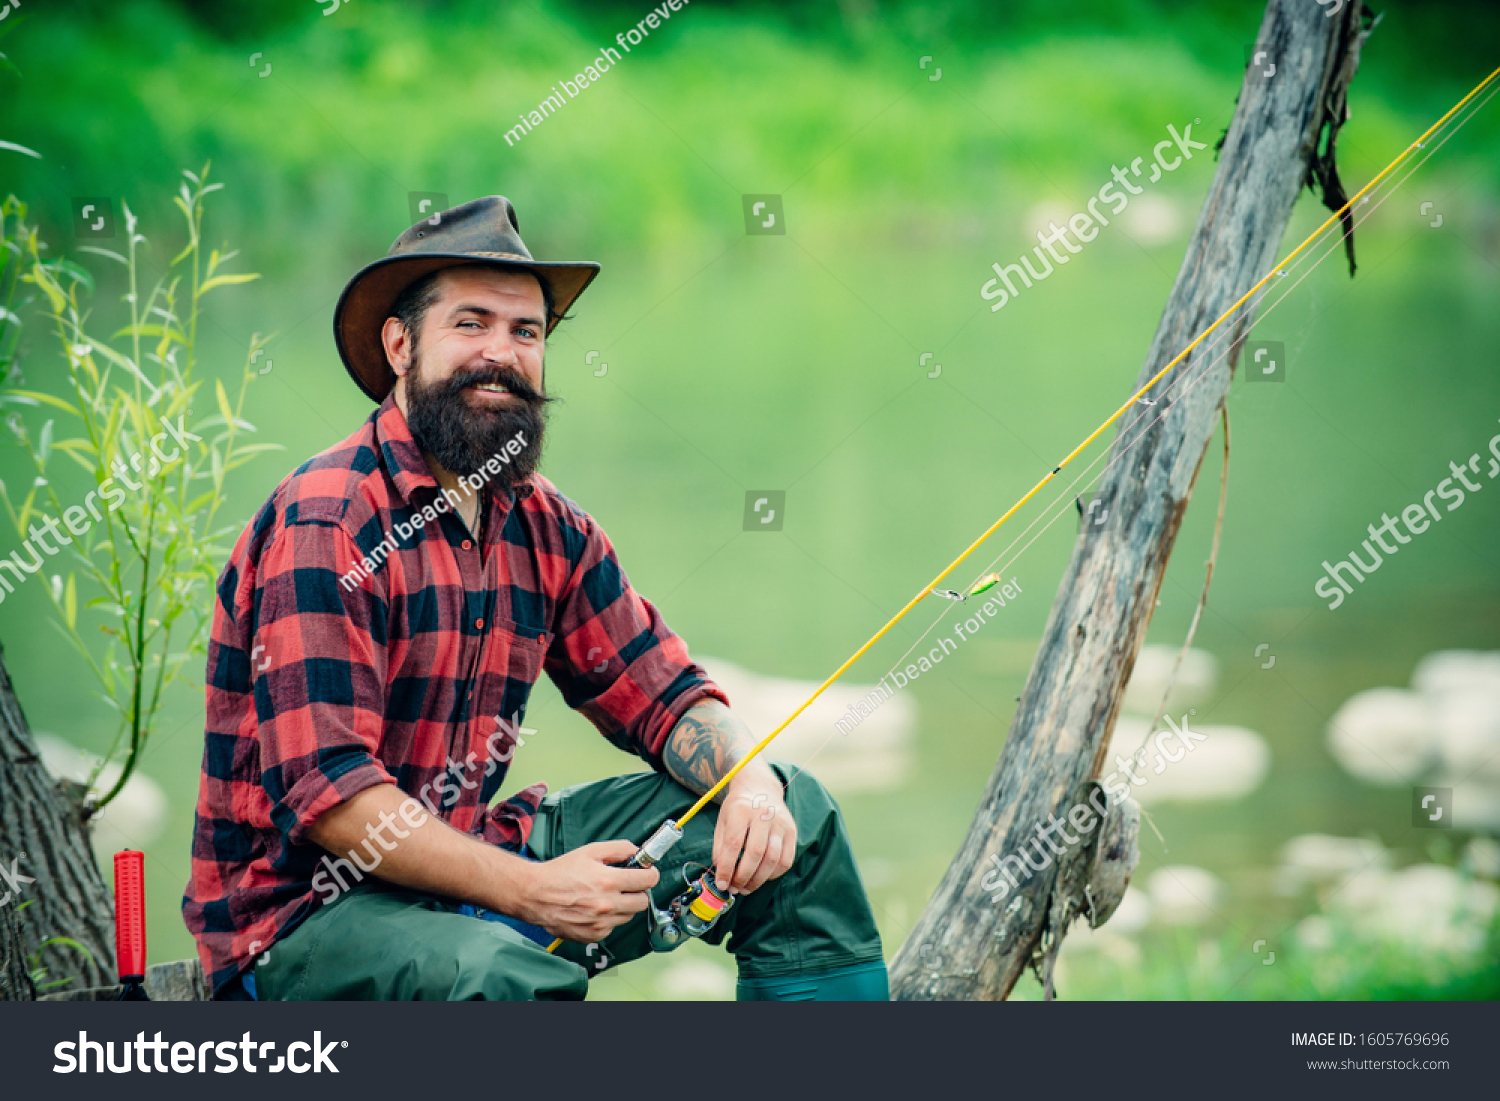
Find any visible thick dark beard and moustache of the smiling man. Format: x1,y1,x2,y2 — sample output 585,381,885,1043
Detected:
407,348,554,489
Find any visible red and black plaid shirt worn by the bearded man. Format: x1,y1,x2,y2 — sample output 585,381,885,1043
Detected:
183,398,729,993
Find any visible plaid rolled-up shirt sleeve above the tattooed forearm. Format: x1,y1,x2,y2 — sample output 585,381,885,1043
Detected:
545,510,729,773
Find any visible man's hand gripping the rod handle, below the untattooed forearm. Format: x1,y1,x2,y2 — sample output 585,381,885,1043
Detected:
518,842,660,944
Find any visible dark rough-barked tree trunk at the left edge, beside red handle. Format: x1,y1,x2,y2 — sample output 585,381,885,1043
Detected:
0,647,117,999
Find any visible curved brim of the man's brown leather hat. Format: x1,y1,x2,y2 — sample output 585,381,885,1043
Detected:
333,252,599,402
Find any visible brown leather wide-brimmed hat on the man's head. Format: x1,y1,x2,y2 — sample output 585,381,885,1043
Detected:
333,195,599,402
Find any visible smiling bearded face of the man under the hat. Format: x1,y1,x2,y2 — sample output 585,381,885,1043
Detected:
384,269,549,485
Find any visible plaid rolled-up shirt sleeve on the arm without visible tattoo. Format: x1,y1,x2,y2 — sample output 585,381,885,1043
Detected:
251,519,396,845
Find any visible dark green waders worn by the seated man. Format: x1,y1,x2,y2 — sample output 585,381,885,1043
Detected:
255,762,890,1001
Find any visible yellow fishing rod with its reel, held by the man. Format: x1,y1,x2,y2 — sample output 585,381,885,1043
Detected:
548,62,1500,953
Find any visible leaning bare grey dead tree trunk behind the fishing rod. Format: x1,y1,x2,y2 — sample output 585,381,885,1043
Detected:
891,0,1368,999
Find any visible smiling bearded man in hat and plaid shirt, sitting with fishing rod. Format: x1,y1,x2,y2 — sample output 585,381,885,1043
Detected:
183,195,888,1001
